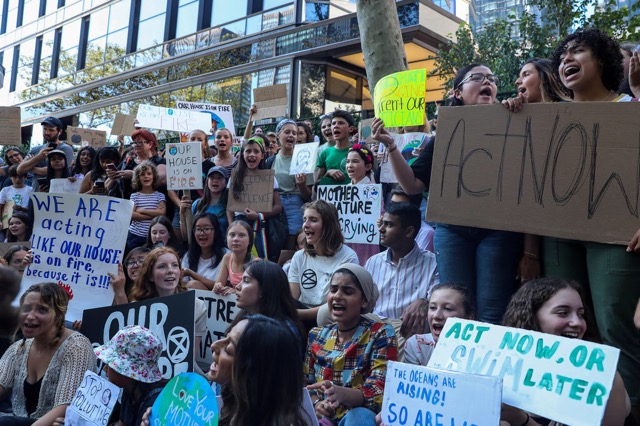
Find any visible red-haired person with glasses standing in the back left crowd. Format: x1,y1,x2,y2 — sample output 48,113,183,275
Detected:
105,129,167,199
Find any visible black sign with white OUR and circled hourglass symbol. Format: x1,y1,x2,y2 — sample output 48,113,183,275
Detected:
82,291,196,379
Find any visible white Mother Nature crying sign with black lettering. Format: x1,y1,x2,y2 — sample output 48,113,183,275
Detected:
318,184,382,244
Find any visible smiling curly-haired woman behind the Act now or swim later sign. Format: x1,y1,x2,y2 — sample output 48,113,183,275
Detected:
501,278,630,426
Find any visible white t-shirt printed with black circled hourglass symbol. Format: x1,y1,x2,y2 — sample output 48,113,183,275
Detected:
288,244,358,306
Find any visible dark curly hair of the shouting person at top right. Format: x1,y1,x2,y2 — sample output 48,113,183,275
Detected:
551,28,624,95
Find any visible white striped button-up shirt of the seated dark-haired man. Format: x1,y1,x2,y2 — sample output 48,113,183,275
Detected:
365,243,440,319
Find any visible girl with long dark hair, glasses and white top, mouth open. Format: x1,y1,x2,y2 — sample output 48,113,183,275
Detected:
182,213,226,290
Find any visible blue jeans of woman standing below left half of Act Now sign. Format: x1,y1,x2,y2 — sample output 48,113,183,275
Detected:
434,224,523,324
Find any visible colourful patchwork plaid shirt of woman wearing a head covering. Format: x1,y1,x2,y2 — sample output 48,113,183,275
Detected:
304,317,398,423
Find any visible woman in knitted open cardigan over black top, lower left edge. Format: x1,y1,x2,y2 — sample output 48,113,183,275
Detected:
0,283,96,426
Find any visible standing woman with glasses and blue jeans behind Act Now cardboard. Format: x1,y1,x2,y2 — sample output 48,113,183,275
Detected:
372,64,522,324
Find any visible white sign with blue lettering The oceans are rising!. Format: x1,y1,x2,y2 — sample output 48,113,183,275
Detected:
382,361,502,426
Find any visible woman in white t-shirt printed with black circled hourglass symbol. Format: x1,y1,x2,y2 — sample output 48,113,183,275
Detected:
288,200,358,324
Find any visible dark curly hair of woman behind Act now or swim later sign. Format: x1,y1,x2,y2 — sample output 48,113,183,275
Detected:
502,278,600,343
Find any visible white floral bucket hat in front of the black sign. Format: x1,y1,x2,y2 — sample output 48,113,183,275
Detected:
94,325,162,383
